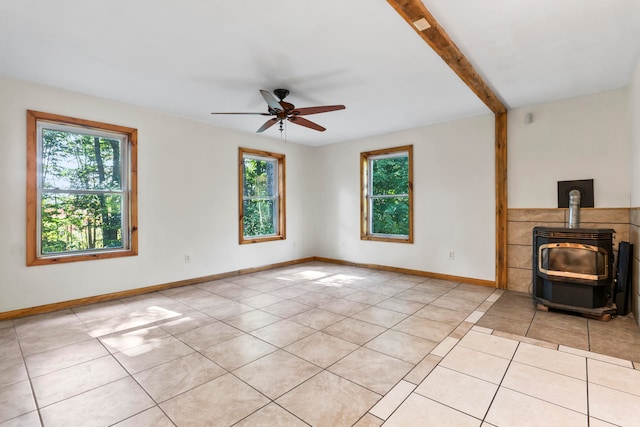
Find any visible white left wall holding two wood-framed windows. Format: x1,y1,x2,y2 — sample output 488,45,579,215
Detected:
0,77,315,312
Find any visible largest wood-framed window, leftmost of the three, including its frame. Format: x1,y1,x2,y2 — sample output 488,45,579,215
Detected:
27,111,138,265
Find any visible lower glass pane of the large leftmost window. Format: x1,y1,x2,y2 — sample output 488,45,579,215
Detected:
41,193,123,254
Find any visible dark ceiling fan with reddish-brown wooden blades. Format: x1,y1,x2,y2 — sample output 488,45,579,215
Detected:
211,89,346,132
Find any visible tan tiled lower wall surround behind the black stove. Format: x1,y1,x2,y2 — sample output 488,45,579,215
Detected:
507,208,640,294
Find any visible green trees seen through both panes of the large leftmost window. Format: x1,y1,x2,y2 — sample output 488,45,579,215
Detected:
41,128,124,255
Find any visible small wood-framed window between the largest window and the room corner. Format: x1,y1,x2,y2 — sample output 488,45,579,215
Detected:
238,148,285,244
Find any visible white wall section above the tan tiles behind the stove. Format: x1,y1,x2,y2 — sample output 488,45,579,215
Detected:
508,89,640,208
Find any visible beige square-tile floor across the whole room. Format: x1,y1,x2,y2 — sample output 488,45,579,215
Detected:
0,263,640,427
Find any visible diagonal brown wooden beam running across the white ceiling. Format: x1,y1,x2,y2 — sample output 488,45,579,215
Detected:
387,0,507,114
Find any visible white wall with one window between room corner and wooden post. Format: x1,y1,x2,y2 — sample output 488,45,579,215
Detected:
316,114,495,280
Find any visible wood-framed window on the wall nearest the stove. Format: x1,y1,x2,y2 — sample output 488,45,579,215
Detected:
360,145,413,243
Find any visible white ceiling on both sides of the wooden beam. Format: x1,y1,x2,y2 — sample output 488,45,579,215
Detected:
0,0,640,145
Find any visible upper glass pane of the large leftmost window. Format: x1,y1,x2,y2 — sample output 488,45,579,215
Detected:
42,129,122,190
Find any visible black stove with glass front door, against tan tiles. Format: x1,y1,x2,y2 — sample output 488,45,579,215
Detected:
533,227,615,308
